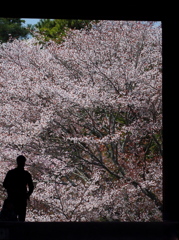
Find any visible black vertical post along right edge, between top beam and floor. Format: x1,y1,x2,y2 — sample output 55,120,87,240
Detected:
162,16,179,222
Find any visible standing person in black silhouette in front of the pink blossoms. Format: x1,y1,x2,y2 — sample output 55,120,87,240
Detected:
3,155,34,222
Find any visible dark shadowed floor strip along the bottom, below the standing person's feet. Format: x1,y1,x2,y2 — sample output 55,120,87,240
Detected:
0,222,179,240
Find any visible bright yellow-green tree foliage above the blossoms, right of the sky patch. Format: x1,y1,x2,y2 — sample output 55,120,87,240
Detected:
35,19,97,43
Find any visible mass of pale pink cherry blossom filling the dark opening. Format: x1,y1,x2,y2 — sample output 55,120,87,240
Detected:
0,21,163,222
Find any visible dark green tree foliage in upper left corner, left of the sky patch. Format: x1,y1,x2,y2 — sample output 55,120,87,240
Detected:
0,18,29,43
